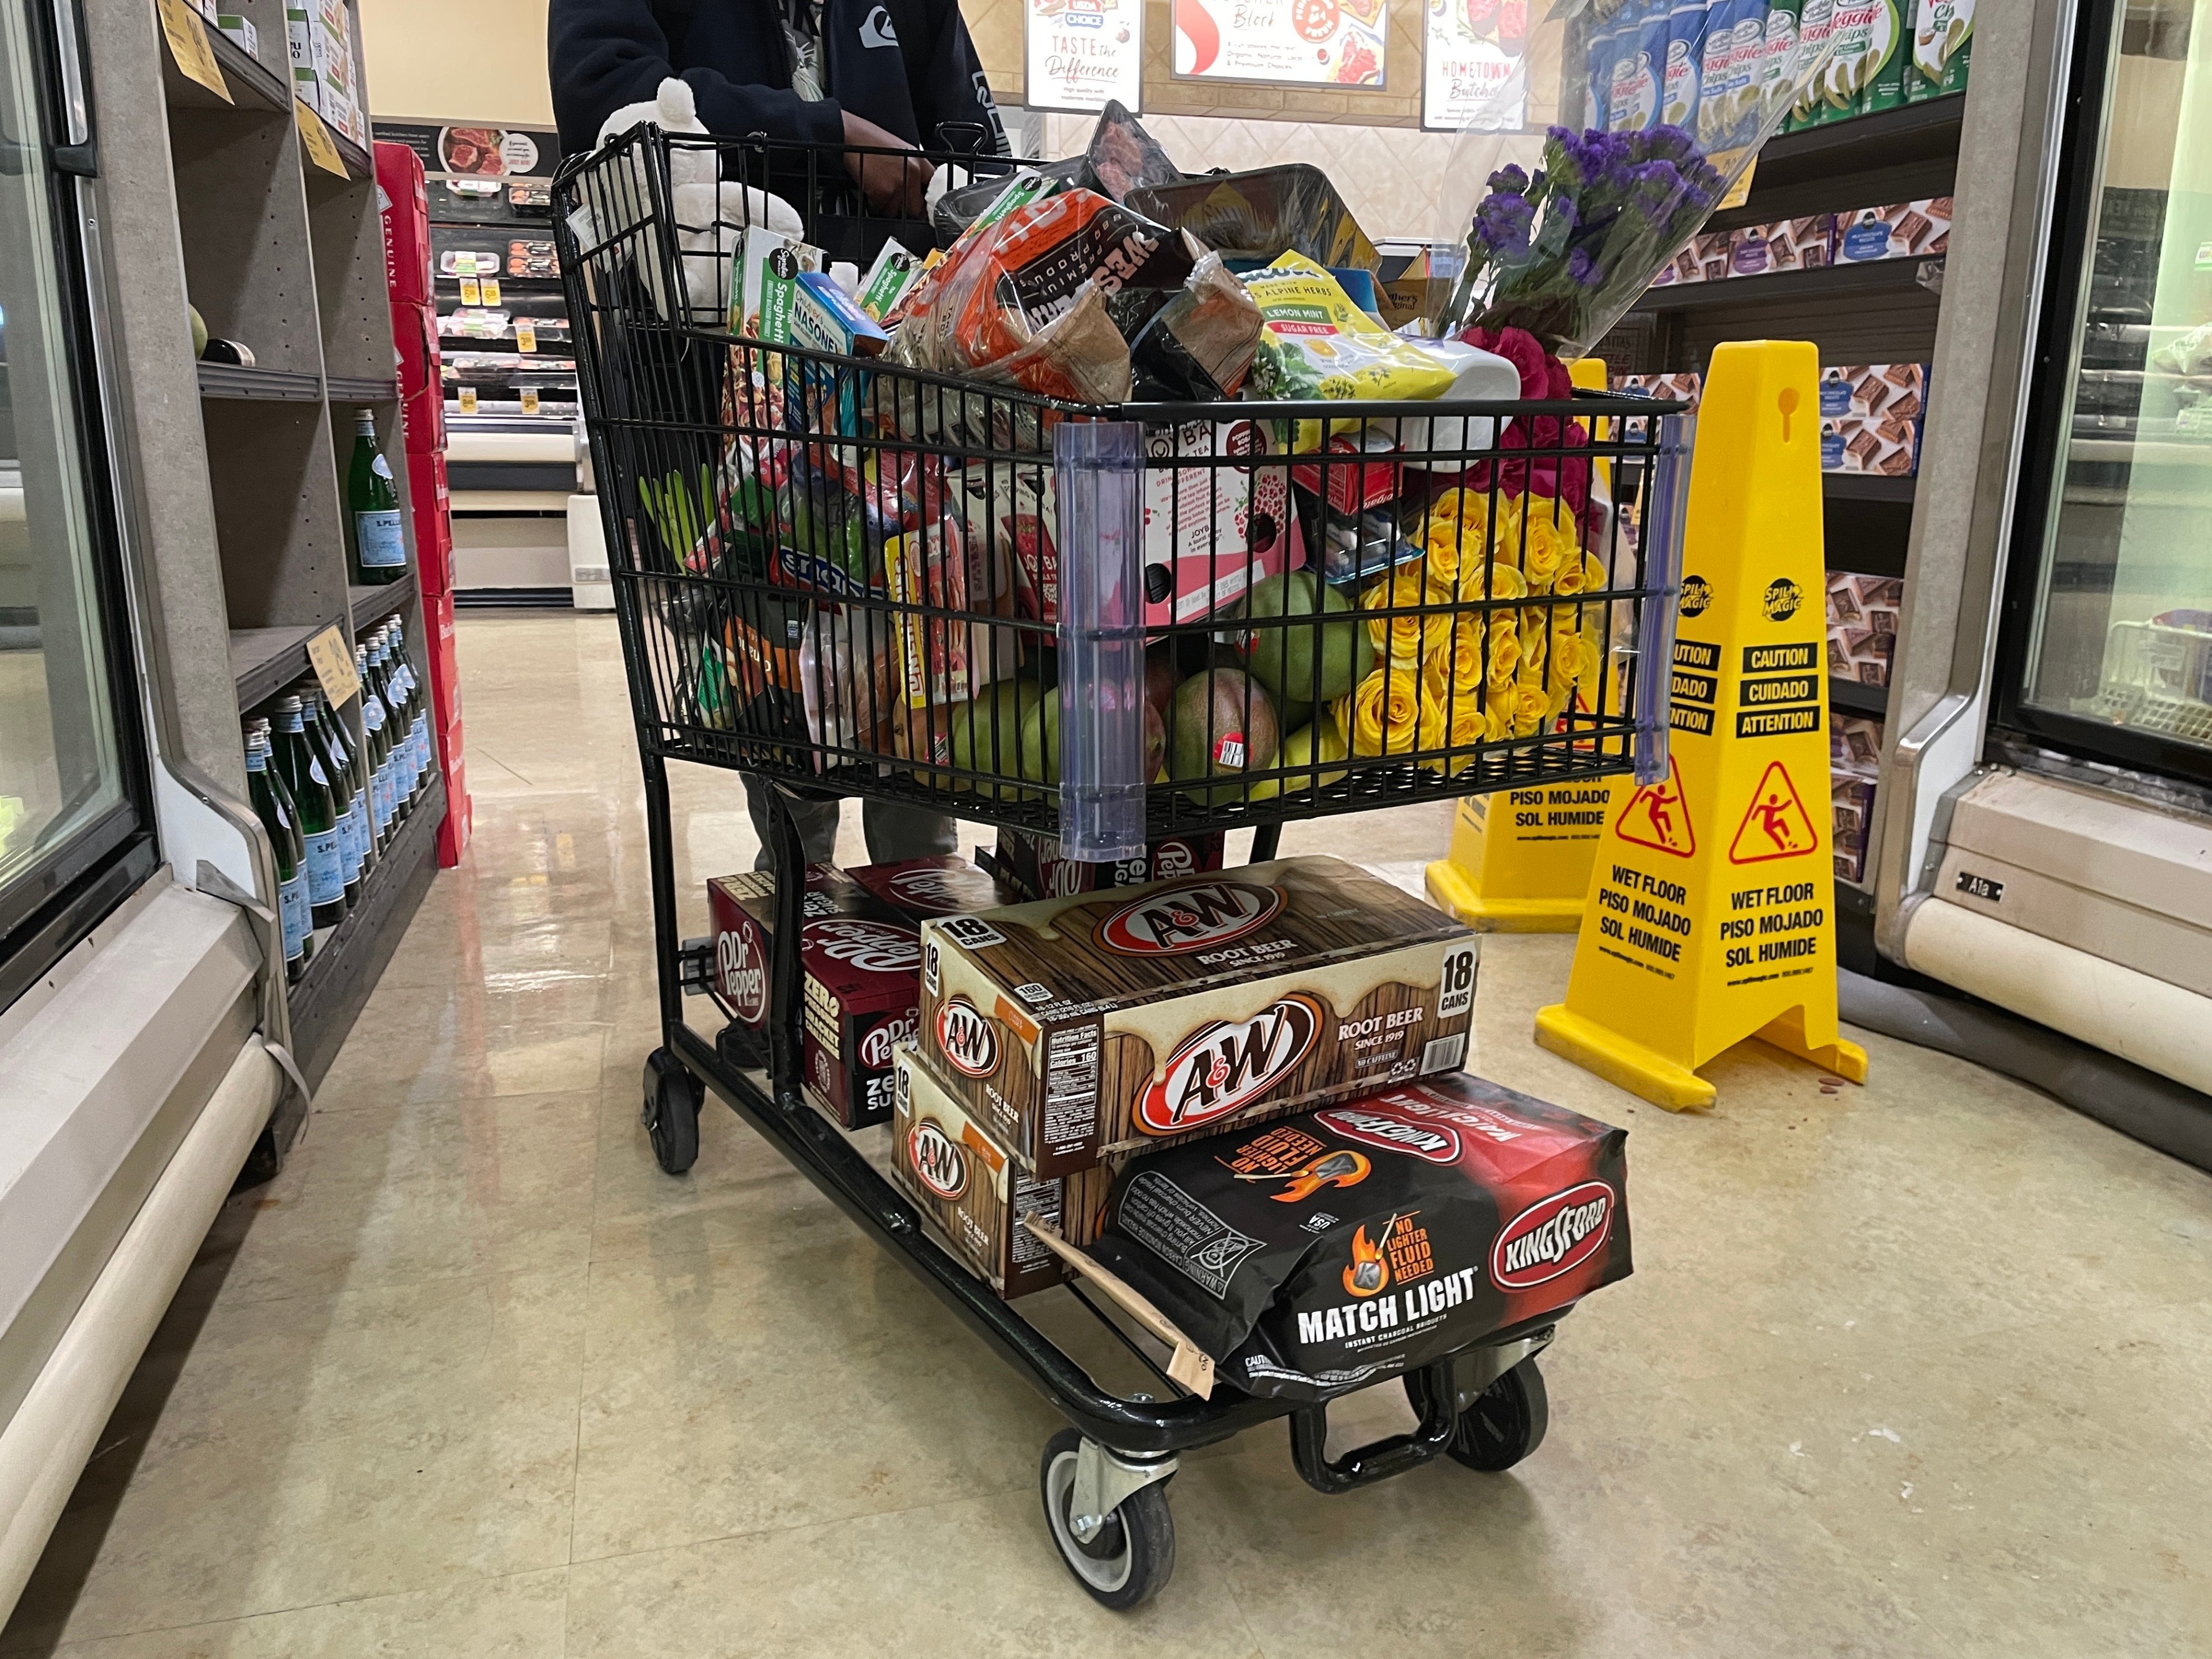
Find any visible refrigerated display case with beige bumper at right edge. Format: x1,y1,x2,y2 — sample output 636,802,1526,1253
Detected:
1876,0,2212,1119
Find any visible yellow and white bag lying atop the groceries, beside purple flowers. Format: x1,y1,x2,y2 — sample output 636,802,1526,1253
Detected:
1243,255,1453,451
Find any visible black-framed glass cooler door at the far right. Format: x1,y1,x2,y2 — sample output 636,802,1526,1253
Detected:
1998,0,2212,779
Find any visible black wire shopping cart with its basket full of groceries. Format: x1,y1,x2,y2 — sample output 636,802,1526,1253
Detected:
555,128,1688,1606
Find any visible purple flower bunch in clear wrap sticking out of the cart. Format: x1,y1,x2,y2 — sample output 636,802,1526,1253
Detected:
1445,126,1725,352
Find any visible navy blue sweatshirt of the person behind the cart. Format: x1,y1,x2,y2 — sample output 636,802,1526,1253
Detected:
546,0,1006,155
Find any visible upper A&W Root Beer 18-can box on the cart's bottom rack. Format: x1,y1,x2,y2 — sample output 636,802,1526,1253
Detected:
920,858,1478,1175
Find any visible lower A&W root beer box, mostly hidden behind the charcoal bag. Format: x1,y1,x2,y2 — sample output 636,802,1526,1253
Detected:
892,1042,1113,1298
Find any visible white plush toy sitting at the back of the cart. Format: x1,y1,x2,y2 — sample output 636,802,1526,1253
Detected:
584,75,805,325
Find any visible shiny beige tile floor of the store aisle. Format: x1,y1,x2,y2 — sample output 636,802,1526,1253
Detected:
0,617,2212,1659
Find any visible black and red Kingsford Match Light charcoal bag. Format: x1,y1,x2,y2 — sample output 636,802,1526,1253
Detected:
1093,1075,1630,1400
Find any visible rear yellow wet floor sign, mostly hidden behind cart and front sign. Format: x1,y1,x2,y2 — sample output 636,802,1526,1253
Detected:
1429,356,1628,933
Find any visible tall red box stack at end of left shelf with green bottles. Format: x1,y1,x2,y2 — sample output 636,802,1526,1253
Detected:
372,144,476,867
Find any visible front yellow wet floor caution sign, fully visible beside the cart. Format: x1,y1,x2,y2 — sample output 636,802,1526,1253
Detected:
1539,340,1867,1111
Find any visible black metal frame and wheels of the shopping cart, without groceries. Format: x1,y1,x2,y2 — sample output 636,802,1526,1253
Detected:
555,135,1688,1606
